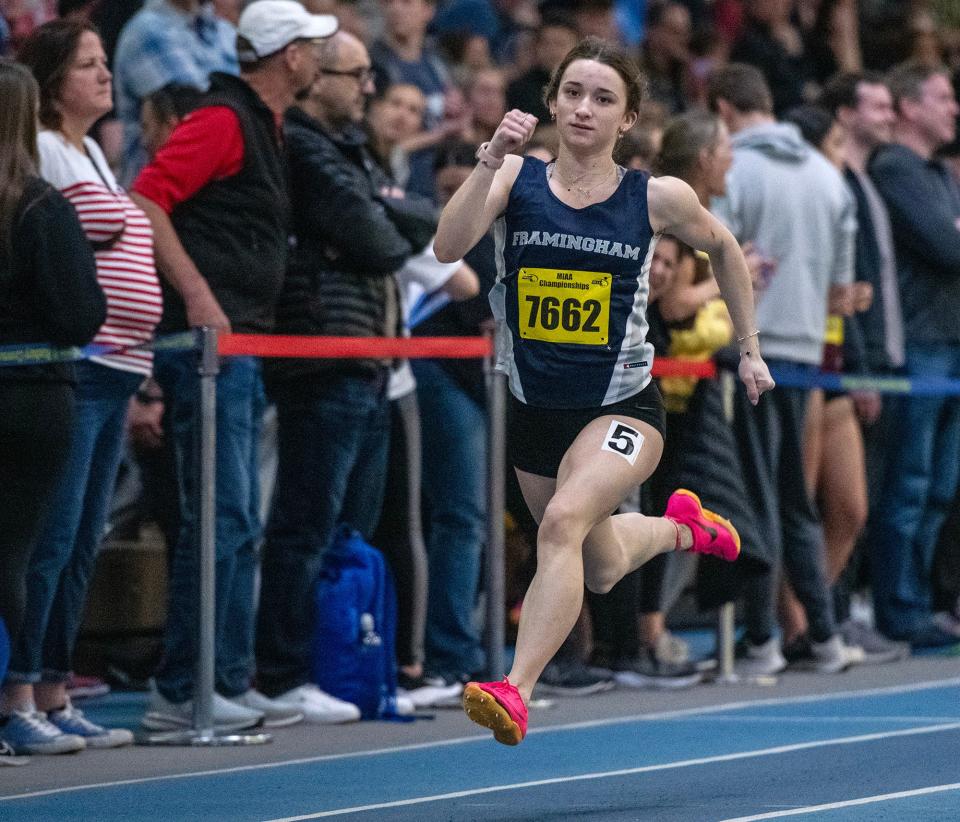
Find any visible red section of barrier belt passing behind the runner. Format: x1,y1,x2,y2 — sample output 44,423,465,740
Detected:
217,334,717,377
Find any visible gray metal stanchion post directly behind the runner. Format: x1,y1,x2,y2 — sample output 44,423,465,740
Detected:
484,337,507,679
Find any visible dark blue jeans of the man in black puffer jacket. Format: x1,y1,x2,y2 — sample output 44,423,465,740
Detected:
257,375,390,696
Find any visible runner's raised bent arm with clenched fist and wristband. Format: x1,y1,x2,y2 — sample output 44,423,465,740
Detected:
433,109,537,263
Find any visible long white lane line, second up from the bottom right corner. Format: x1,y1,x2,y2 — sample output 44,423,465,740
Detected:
269,722,960,822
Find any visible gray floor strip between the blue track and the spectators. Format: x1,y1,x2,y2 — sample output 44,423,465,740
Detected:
0,656,960,800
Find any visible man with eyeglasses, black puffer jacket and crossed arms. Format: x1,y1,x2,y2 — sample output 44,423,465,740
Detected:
256,27,436,723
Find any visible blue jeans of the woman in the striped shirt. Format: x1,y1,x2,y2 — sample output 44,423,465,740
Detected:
6,362,143,683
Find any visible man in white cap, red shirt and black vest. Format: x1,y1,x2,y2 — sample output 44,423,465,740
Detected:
132,0,337,730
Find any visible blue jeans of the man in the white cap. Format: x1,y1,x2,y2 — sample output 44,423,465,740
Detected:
155,352,266,703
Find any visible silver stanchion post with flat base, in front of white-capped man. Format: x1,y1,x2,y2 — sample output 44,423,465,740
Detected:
137,326,272,747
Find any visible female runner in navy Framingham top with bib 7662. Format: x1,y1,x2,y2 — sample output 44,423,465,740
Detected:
434,38,774,745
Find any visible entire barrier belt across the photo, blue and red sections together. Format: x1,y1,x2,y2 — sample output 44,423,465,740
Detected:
0,331,960,397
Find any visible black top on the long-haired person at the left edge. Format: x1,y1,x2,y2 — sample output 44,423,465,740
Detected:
0,178,107,381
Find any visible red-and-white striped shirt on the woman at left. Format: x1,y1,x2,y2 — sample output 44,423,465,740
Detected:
38,131,163,375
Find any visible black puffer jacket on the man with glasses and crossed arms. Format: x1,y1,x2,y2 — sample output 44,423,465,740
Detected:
267,108,437,384
